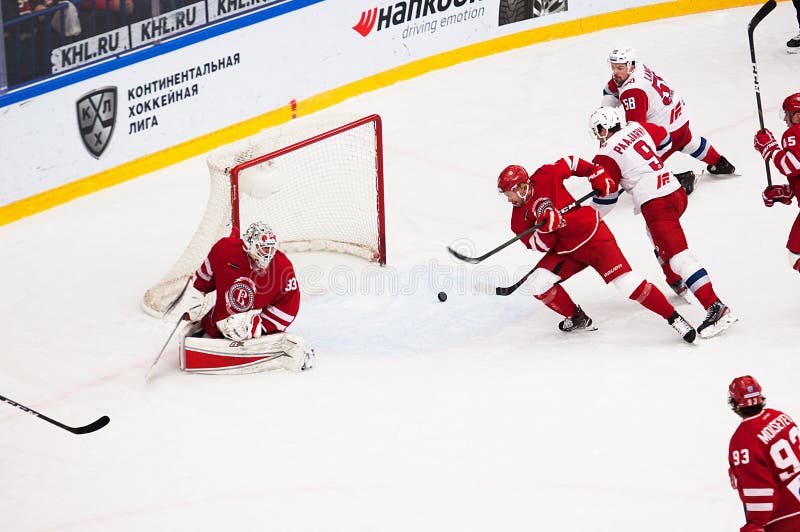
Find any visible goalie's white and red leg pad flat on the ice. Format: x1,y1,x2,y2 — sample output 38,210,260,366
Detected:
180,322,315,375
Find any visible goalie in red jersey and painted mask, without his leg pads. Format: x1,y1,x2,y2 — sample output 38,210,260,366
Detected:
183,222,300,341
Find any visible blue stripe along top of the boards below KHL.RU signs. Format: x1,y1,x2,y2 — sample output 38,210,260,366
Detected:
0,0,325,109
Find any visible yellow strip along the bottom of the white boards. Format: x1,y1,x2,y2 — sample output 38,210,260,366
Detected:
0,0,786,226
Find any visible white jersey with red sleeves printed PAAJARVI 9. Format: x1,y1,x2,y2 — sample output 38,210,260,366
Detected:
592,122,680,214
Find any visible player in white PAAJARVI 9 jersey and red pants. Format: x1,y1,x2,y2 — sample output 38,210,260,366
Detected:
589,107,736,338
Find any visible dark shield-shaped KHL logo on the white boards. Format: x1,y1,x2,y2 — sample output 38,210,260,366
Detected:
75,87,117,159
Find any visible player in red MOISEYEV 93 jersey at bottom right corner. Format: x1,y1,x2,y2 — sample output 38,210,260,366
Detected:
728,375,800,532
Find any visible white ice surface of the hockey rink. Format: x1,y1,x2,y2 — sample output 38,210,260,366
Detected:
0,2,800,532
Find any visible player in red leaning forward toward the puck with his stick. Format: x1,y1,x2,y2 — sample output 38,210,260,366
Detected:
497,161,696,343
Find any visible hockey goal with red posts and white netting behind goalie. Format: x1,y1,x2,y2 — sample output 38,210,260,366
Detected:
142,115,386,316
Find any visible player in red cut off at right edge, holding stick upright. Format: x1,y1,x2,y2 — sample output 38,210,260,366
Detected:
753,92,800,272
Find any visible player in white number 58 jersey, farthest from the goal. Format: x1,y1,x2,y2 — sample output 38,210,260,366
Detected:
600,46,736,194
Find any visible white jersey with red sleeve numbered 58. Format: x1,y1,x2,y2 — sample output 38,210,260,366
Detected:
602,64,689,132
